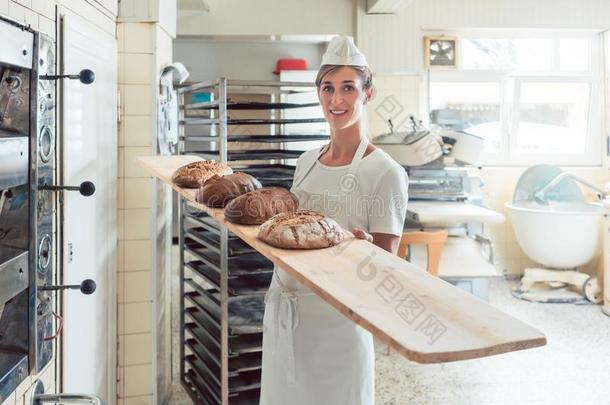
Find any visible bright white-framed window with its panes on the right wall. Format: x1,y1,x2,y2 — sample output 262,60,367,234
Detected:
429,31,602,165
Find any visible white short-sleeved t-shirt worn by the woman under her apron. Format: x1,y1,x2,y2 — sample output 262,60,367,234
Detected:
291,148,409,236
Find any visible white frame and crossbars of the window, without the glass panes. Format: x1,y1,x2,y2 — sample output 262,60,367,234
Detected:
424,30,606,166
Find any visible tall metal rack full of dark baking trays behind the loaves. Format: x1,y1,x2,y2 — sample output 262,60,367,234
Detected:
178,78,329,405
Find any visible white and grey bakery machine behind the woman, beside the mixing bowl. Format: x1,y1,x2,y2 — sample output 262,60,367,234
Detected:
373,115,504,299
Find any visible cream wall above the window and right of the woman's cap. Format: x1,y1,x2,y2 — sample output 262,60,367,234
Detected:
356,0,610,74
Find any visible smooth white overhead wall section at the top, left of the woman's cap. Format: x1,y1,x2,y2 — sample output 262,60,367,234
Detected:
178,0,355,35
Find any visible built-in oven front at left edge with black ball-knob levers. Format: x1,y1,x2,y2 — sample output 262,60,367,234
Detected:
0,15,95,402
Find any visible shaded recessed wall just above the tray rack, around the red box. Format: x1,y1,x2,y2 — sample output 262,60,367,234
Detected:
174,38,326,82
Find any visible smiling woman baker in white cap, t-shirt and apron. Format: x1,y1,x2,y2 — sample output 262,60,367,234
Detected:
260,37,408,405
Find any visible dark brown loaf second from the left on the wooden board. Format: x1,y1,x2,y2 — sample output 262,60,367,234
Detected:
197,172,262,207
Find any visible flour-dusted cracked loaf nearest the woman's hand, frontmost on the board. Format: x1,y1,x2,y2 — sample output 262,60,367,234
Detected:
258,210,346,249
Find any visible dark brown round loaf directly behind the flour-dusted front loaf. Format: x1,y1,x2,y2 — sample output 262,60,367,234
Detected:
225,187,299,225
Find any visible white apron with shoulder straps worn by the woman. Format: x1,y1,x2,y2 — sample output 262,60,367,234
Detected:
260,139,375,405
